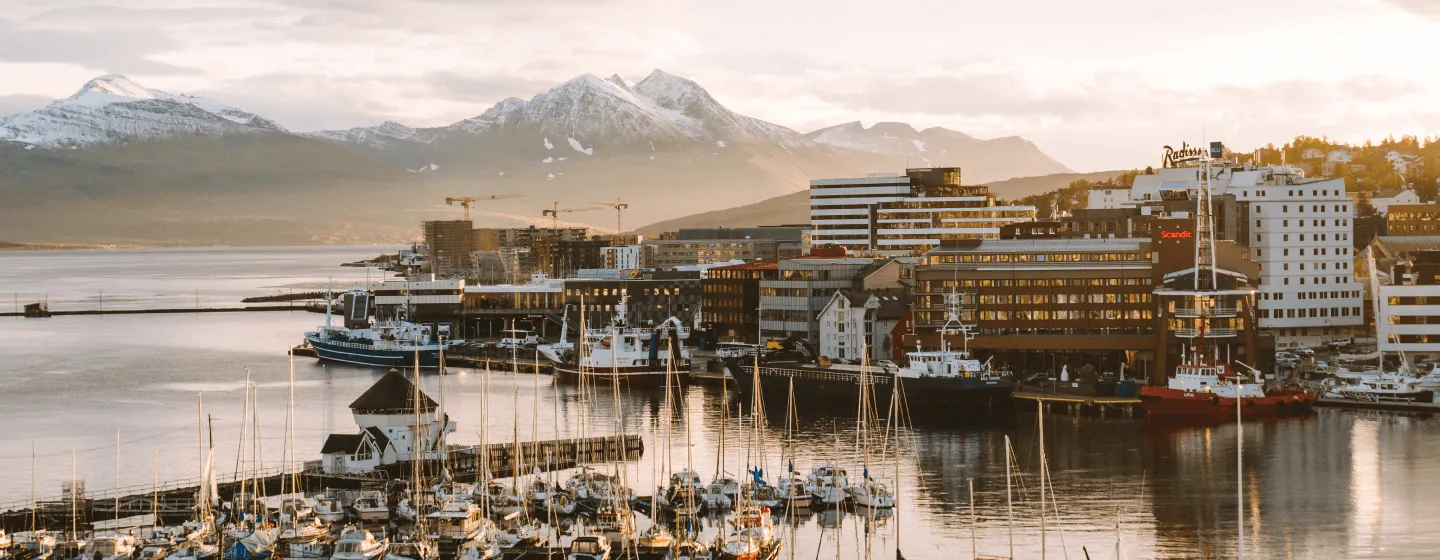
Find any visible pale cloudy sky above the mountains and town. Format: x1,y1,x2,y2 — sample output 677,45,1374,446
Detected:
0,0,1440,171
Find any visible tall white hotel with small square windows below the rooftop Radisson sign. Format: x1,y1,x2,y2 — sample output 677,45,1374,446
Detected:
1129,166,1364,348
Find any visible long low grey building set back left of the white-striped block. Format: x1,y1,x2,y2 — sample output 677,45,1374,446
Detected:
645,226,809,268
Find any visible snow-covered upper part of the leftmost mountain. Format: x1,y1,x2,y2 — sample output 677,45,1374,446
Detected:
0,75,285,147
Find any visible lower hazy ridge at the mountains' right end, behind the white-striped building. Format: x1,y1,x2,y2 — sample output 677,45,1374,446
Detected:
805,121,1070,183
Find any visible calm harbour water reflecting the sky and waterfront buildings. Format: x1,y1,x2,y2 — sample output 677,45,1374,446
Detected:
0,248,1440,559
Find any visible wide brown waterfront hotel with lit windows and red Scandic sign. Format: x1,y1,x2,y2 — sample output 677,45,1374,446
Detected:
903,219,1273,377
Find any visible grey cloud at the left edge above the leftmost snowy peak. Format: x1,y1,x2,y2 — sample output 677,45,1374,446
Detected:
0,19,192,75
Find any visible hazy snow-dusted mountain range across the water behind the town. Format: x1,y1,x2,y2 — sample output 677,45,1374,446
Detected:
0,71,1068,245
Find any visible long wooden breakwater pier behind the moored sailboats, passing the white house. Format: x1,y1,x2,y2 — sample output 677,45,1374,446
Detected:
0,435,645,533
